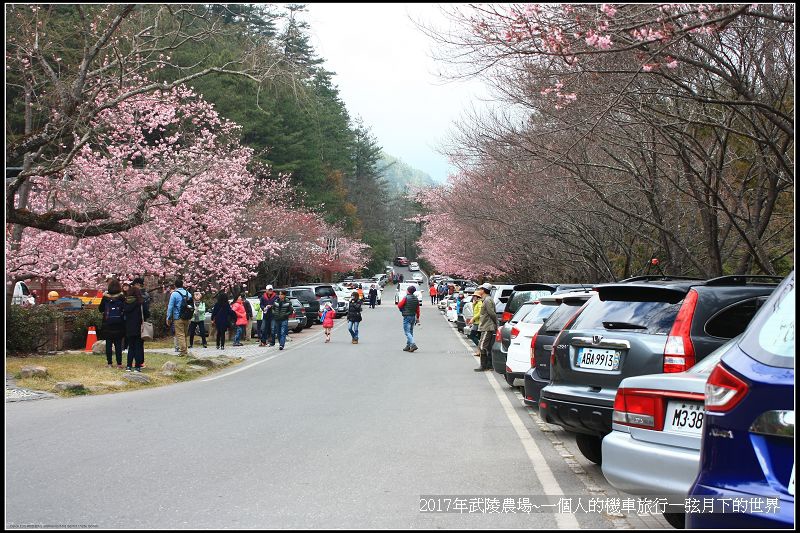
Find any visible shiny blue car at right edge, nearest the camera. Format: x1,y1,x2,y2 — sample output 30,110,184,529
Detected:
686,272,795,529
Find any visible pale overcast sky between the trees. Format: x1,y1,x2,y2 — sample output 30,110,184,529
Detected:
303,3,487,181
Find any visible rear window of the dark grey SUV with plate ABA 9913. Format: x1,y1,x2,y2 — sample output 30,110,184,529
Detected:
570,299,681,335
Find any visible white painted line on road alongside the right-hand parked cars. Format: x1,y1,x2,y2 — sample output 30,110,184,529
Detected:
448,323,580,529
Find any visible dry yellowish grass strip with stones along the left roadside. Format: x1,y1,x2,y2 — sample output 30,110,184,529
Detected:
6,352,243,397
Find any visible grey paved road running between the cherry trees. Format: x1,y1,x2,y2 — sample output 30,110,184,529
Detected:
6,268,668,529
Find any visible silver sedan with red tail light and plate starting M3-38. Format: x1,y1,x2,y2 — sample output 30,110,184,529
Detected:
603,337,738,528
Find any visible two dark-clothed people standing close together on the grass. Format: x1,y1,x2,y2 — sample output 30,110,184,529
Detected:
98,278,150,372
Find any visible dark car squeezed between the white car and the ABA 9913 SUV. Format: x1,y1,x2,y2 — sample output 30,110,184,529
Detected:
523,291,597,407
